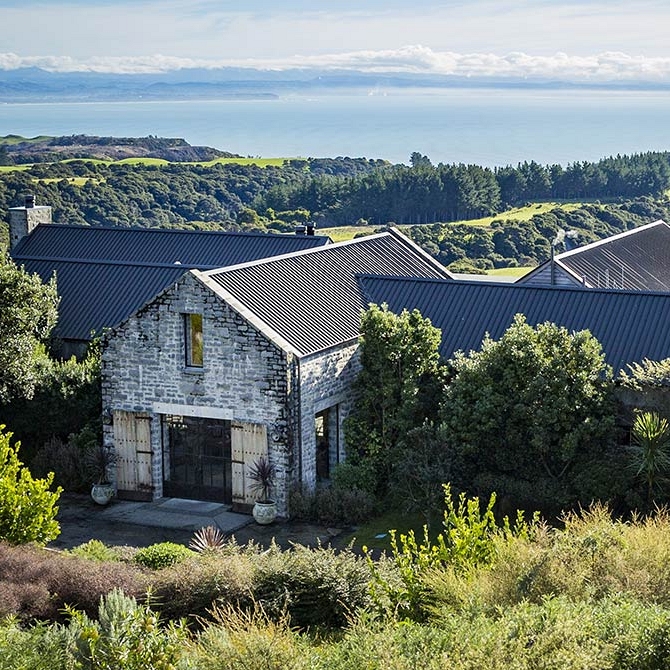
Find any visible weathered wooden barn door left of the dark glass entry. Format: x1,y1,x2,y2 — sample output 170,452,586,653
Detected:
114,410,153,500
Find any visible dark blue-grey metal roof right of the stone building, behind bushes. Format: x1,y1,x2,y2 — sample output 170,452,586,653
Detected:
359,277,670,372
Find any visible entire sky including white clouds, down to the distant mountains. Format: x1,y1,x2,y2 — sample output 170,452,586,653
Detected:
0,0,670,83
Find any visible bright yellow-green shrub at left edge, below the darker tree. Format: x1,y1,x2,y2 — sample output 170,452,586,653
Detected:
0,425,62,544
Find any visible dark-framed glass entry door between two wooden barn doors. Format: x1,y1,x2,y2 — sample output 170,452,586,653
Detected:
163,416,232,503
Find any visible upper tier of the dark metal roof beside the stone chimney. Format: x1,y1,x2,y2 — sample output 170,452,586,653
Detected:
12,223,329,269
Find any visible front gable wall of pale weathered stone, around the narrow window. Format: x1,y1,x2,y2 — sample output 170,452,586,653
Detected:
102,273,292,514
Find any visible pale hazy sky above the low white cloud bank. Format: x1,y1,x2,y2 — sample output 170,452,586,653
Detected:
0,0,670,60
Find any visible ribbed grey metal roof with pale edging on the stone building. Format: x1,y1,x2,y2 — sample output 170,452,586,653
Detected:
204,231,451,355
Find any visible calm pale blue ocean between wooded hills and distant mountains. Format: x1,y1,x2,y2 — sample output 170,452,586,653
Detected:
0,89,670,167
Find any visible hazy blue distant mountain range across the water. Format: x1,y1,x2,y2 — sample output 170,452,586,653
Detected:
0,68,670,103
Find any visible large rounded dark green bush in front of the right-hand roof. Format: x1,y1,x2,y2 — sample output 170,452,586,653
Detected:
441,315,614,512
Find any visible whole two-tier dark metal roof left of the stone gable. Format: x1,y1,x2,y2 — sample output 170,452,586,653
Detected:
12,224,329,340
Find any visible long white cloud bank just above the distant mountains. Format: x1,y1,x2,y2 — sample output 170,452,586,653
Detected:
0,45,670,83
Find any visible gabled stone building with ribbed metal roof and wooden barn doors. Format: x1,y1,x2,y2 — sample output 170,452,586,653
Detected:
102,231,451,515
